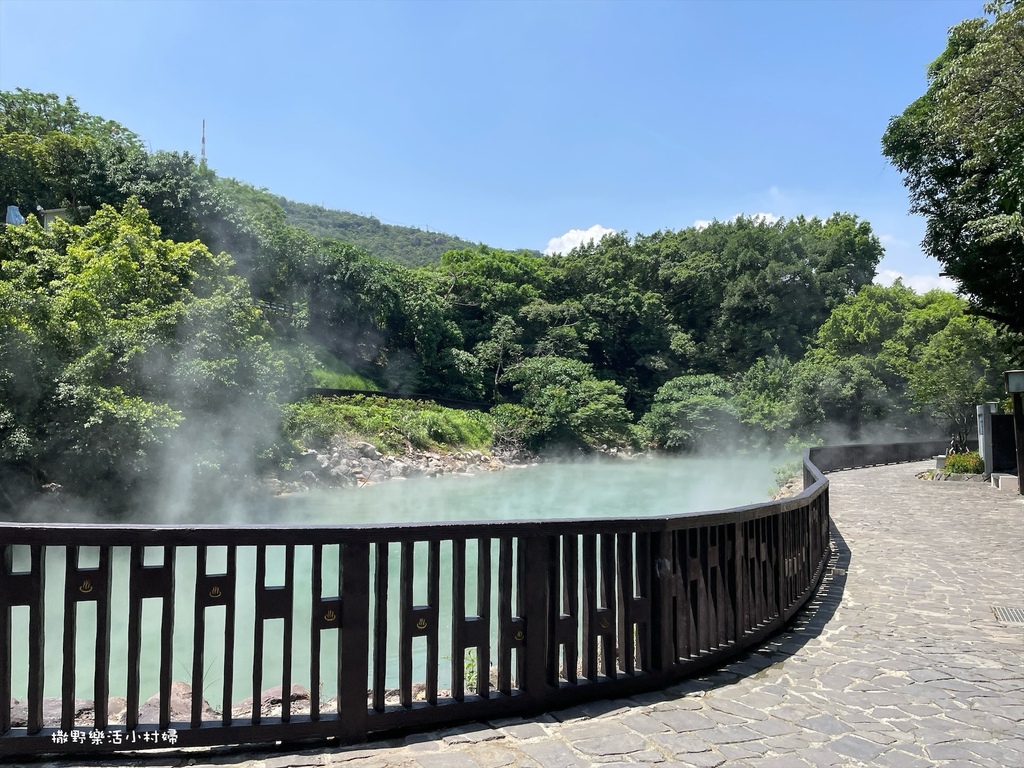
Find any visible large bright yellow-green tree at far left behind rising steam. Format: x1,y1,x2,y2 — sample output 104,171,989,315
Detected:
0,200,294,512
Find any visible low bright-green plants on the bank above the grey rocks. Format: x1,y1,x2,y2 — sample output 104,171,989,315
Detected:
285,395,494,454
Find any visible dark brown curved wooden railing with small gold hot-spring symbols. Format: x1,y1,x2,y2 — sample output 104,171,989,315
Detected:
0,443,941,756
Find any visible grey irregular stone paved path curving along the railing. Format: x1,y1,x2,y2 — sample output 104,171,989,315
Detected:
24,464,1024,768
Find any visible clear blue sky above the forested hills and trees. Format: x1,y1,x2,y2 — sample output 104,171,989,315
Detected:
0,0,983,288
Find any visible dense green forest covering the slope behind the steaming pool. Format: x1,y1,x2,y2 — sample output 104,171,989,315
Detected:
0,82,1021,518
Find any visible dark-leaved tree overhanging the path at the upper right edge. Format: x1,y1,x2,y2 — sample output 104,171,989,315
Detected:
882,2,1024,333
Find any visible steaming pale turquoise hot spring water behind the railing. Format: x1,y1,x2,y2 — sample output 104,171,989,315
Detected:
6,458,778,709
